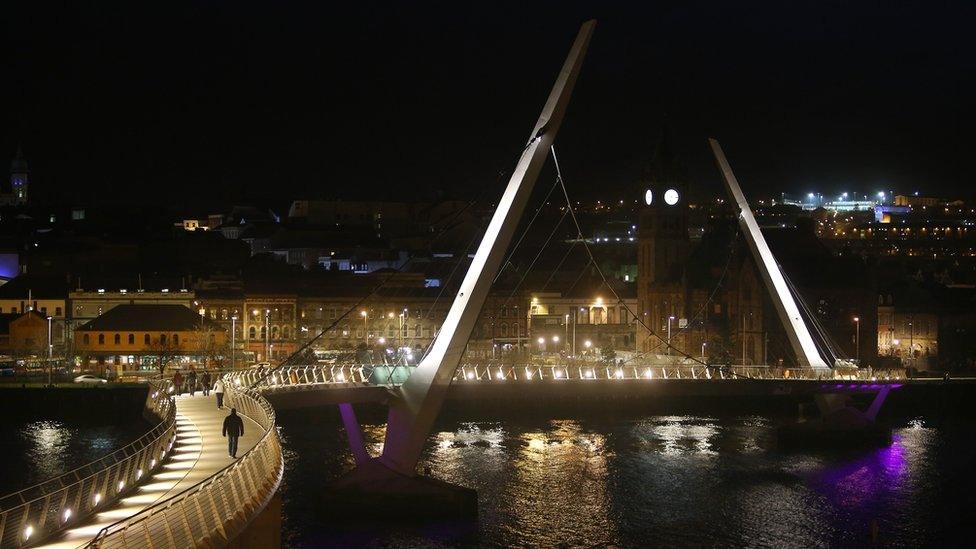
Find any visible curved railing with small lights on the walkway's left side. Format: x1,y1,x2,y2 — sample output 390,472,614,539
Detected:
0,379,176,547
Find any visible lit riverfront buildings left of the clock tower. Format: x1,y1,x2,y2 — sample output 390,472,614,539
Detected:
0,272,636,370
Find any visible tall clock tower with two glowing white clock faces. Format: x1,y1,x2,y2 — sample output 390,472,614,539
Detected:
637,131,690,348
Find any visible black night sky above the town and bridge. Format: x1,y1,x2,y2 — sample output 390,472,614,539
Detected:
0,1,976,206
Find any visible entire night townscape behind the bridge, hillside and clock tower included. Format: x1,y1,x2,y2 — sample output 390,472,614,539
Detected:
0,140,976,370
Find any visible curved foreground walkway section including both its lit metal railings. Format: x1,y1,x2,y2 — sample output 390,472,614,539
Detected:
0,375,284,548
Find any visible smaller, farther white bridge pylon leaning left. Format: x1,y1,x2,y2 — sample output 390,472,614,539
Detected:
708,139,830,370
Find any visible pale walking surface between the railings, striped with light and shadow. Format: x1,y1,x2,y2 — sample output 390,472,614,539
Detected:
42,393,264,549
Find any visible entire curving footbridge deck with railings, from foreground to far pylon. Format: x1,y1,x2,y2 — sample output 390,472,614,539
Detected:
0,362,904,548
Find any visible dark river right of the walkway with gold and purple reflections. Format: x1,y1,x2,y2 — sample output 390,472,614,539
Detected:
279,416,974,547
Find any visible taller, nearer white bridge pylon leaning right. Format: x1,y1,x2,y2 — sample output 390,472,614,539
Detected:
376,20,596,475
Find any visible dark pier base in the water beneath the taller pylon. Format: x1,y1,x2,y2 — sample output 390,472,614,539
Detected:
325,459,478,520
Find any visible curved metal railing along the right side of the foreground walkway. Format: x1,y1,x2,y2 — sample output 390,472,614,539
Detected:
88,371,284,548
